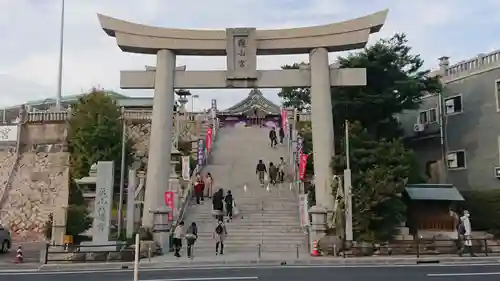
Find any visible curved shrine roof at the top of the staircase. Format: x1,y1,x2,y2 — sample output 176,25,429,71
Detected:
222,89,281,114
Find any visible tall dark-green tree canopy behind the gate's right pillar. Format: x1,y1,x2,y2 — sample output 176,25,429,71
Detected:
278,34,442,138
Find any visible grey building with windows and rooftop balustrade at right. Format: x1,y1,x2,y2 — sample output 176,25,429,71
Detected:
399,51,500,190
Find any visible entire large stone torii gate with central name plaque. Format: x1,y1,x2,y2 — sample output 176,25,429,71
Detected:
98,10,388,227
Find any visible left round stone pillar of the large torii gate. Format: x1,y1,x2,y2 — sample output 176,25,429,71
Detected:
142,50,175,228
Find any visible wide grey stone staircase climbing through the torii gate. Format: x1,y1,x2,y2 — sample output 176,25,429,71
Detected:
185,127,307,258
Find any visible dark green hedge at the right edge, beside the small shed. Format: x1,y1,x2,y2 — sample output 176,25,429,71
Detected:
461,189,500,235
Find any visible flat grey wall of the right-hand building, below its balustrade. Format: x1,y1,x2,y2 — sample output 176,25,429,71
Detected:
444,68,500,189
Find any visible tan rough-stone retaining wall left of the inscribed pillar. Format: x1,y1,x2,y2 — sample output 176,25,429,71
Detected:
1,152,69,241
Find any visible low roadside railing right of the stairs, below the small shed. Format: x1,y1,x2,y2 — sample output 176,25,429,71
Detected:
319,239,500,258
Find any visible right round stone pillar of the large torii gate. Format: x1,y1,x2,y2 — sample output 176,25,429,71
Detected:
309,48,334,211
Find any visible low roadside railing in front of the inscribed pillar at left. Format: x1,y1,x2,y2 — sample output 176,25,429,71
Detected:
42,244,135,264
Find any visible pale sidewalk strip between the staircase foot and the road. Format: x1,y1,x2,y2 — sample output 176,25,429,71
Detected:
39,255,500,271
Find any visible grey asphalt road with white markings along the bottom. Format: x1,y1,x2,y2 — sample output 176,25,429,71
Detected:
0,264,500,281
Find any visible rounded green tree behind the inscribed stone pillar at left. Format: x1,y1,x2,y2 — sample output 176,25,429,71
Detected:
66,89,132,235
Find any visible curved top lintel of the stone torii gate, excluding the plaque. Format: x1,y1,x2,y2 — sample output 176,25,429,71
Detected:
98,10,389,56
